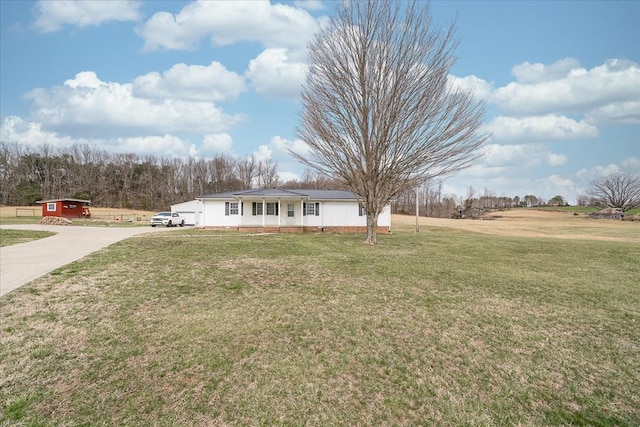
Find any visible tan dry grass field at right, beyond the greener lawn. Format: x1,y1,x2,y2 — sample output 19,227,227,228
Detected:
392,209,640,243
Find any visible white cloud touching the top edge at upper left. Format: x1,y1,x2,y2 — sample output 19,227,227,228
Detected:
33,0,140,33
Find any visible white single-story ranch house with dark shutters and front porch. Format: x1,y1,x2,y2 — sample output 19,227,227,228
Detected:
171,188,391,232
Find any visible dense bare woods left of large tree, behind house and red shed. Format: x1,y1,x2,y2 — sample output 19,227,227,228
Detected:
0,142,322,210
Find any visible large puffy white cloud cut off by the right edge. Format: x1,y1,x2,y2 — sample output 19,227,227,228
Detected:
491,59,640,115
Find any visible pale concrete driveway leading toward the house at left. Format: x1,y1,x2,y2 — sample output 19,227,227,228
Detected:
0,224,176,297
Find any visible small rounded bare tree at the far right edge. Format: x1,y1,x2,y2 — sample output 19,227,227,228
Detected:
590,172,640,212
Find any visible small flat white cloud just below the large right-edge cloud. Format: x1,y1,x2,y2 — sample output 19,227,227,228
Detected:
486,114,598,142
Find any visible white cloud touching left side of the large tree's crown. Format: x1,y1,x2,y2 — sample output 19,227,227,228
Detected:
245,49,306,98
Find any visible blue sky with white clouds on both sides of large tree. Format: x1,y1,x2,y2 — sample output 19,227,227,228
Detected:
0,0,640,203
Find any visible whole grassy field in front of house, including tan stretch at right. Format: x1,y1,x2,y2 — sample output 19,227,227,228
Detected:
0,210,640,426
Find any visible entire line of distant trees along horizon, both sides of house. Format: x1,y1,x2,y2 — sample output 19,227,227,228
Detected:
0,142,640,218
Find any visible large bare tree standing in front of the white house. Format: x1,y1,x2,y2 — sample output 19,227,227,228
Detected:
292,0,486,243
